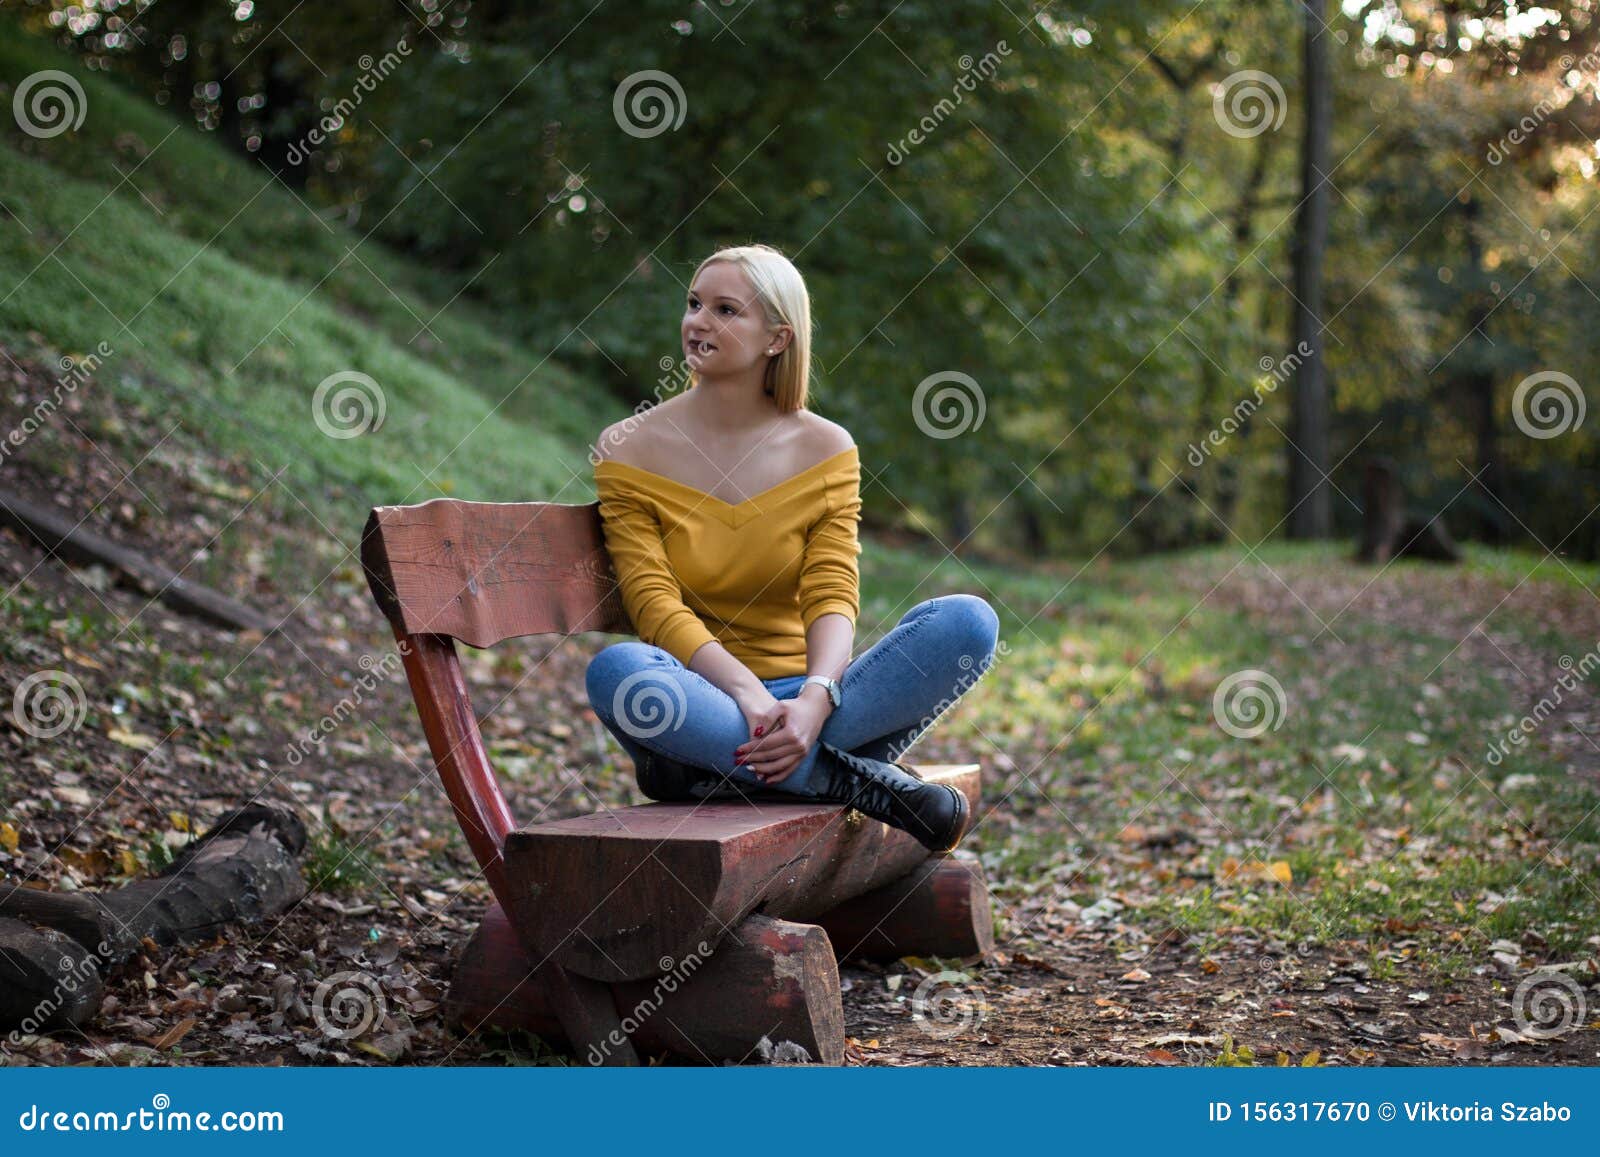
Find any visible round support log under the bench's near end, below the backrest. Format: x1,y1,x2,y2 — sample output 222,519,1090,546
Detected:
445,904,845,1064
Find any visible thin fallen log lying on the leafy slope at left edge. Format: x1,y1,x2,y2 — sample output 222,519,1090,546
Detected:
0,493,283,634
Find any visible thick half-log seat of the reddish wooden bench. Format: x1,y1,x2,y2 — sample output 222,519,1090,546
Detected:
504,763,978,981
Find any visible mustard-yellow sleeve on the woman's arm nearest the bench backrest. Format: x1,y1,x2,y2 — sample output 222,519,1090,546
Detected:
595,474,717,667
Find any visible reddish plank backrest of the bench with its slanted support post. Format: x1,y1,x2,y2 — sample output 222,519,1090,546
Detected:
362,498,635,909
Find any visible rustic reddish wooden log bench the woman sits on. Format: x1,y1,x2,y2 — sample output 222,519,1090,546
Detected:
362,498,994,1064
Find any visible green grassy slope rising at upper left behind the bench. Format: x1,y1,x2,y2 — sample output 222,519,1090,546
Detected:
0,27,622,541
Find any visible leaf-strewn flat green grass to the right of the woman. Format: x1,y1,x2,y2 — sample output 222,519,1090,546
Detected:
862,544,1600,979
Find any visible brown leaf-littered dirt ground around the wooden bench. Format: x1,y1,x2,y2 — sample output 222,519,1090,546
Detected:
0,350,1600,1066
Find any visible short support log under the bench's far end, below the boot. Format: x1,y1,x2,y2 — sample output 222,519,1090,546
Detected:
816,856,995,960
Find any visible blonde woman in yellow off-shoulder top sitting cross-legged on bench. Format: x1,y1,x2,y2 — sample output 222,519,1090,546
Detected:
586,245,998,851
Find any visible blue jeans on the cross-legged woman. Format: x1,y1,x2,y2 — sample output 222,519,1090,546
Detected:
584,594,1000,795
